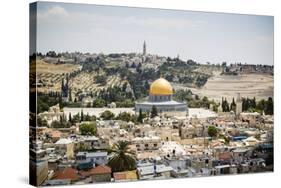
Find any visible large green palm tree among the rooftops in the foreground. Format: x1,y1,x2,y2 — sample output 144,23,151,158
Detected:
108,141,136,172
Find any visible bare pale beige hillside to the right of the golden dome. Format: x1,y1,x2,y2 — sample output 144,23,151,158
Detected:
172,72,274,102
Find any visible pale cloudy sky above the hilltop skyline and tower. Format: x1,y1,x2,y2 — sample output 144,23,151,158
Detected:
34,2,274,65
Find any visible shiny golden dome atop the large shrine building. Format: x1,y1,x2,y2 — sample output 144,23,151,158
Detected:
149,78,173,95
